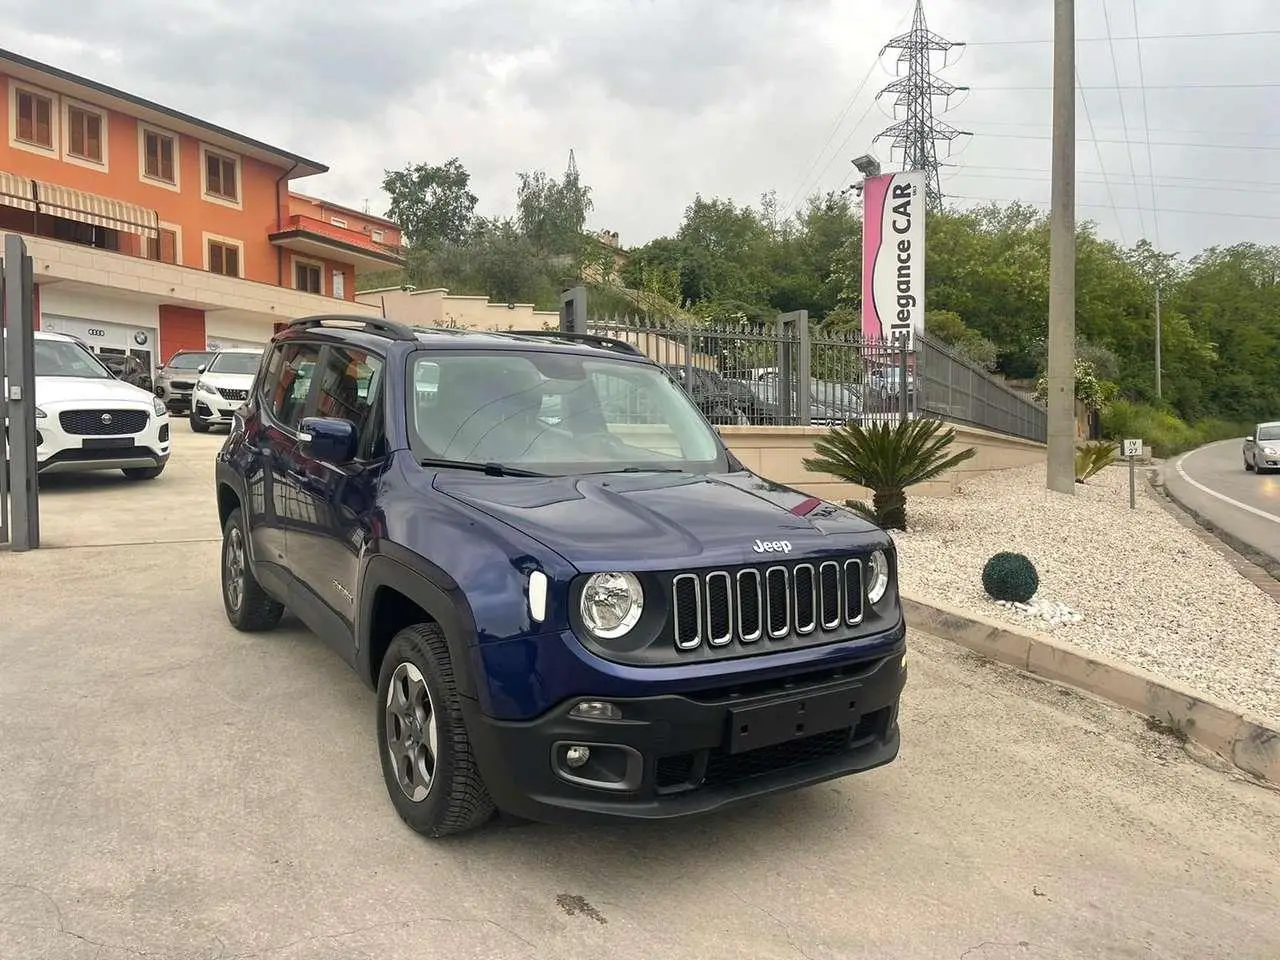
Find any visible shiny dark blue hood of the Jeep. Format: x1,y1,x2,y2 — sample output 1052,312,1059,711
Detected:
433,471,891,571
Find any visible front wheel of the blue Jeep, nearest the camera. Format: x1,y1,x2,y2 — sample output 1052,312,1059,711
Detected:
376,623,494,837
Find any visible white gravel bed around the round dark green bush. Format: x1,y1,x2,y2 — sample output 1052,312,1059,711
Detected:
893,465,1280,723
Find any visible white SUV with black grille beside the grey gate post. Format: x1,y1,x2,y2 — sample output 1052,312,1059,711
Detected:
6,330,169,480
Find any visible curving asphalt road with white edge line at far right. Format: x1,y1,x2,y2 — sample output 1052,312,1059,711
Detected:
1164,438,1280,576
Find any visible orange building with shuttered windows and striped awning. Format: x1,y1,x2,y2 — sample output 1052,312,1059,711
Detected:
0,50,404,369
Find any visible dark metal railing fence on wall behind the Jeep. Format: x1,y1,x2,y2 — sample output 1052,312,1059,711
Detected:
576,302,1046,442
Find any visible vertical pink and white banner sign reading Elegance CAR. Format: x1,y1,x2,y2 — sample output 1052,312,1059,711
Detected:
863,170,925,348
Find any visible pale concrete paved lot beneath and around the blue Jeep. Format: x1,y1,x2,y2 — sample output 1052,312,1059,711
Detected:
0,425,1280,960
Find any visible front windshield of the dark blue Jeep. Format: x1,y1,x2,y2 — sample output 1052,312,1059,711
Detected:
408,351,727,475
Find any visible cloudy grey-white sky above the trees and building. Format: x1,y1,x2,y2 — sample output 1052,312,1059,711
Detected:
0,0,1280,255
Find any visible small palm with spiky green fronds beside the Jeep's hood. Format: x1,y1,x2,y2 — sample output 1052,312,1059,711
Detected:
804,419,975,530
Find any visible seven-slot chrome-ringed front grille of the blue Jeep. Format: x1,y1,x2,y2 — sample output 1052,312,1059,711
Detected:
671,559,863,650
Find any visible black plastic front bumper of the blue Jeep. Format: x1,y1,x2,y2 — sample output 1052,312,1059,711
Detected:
463,644,906,823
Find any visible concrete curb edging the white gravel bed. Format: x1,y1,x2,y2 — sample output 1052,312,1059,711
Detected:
902,596,1280,785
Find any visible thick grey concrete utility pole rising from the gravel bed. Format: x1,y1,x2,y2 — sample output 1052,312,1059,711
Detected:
1047,0,1075,497
